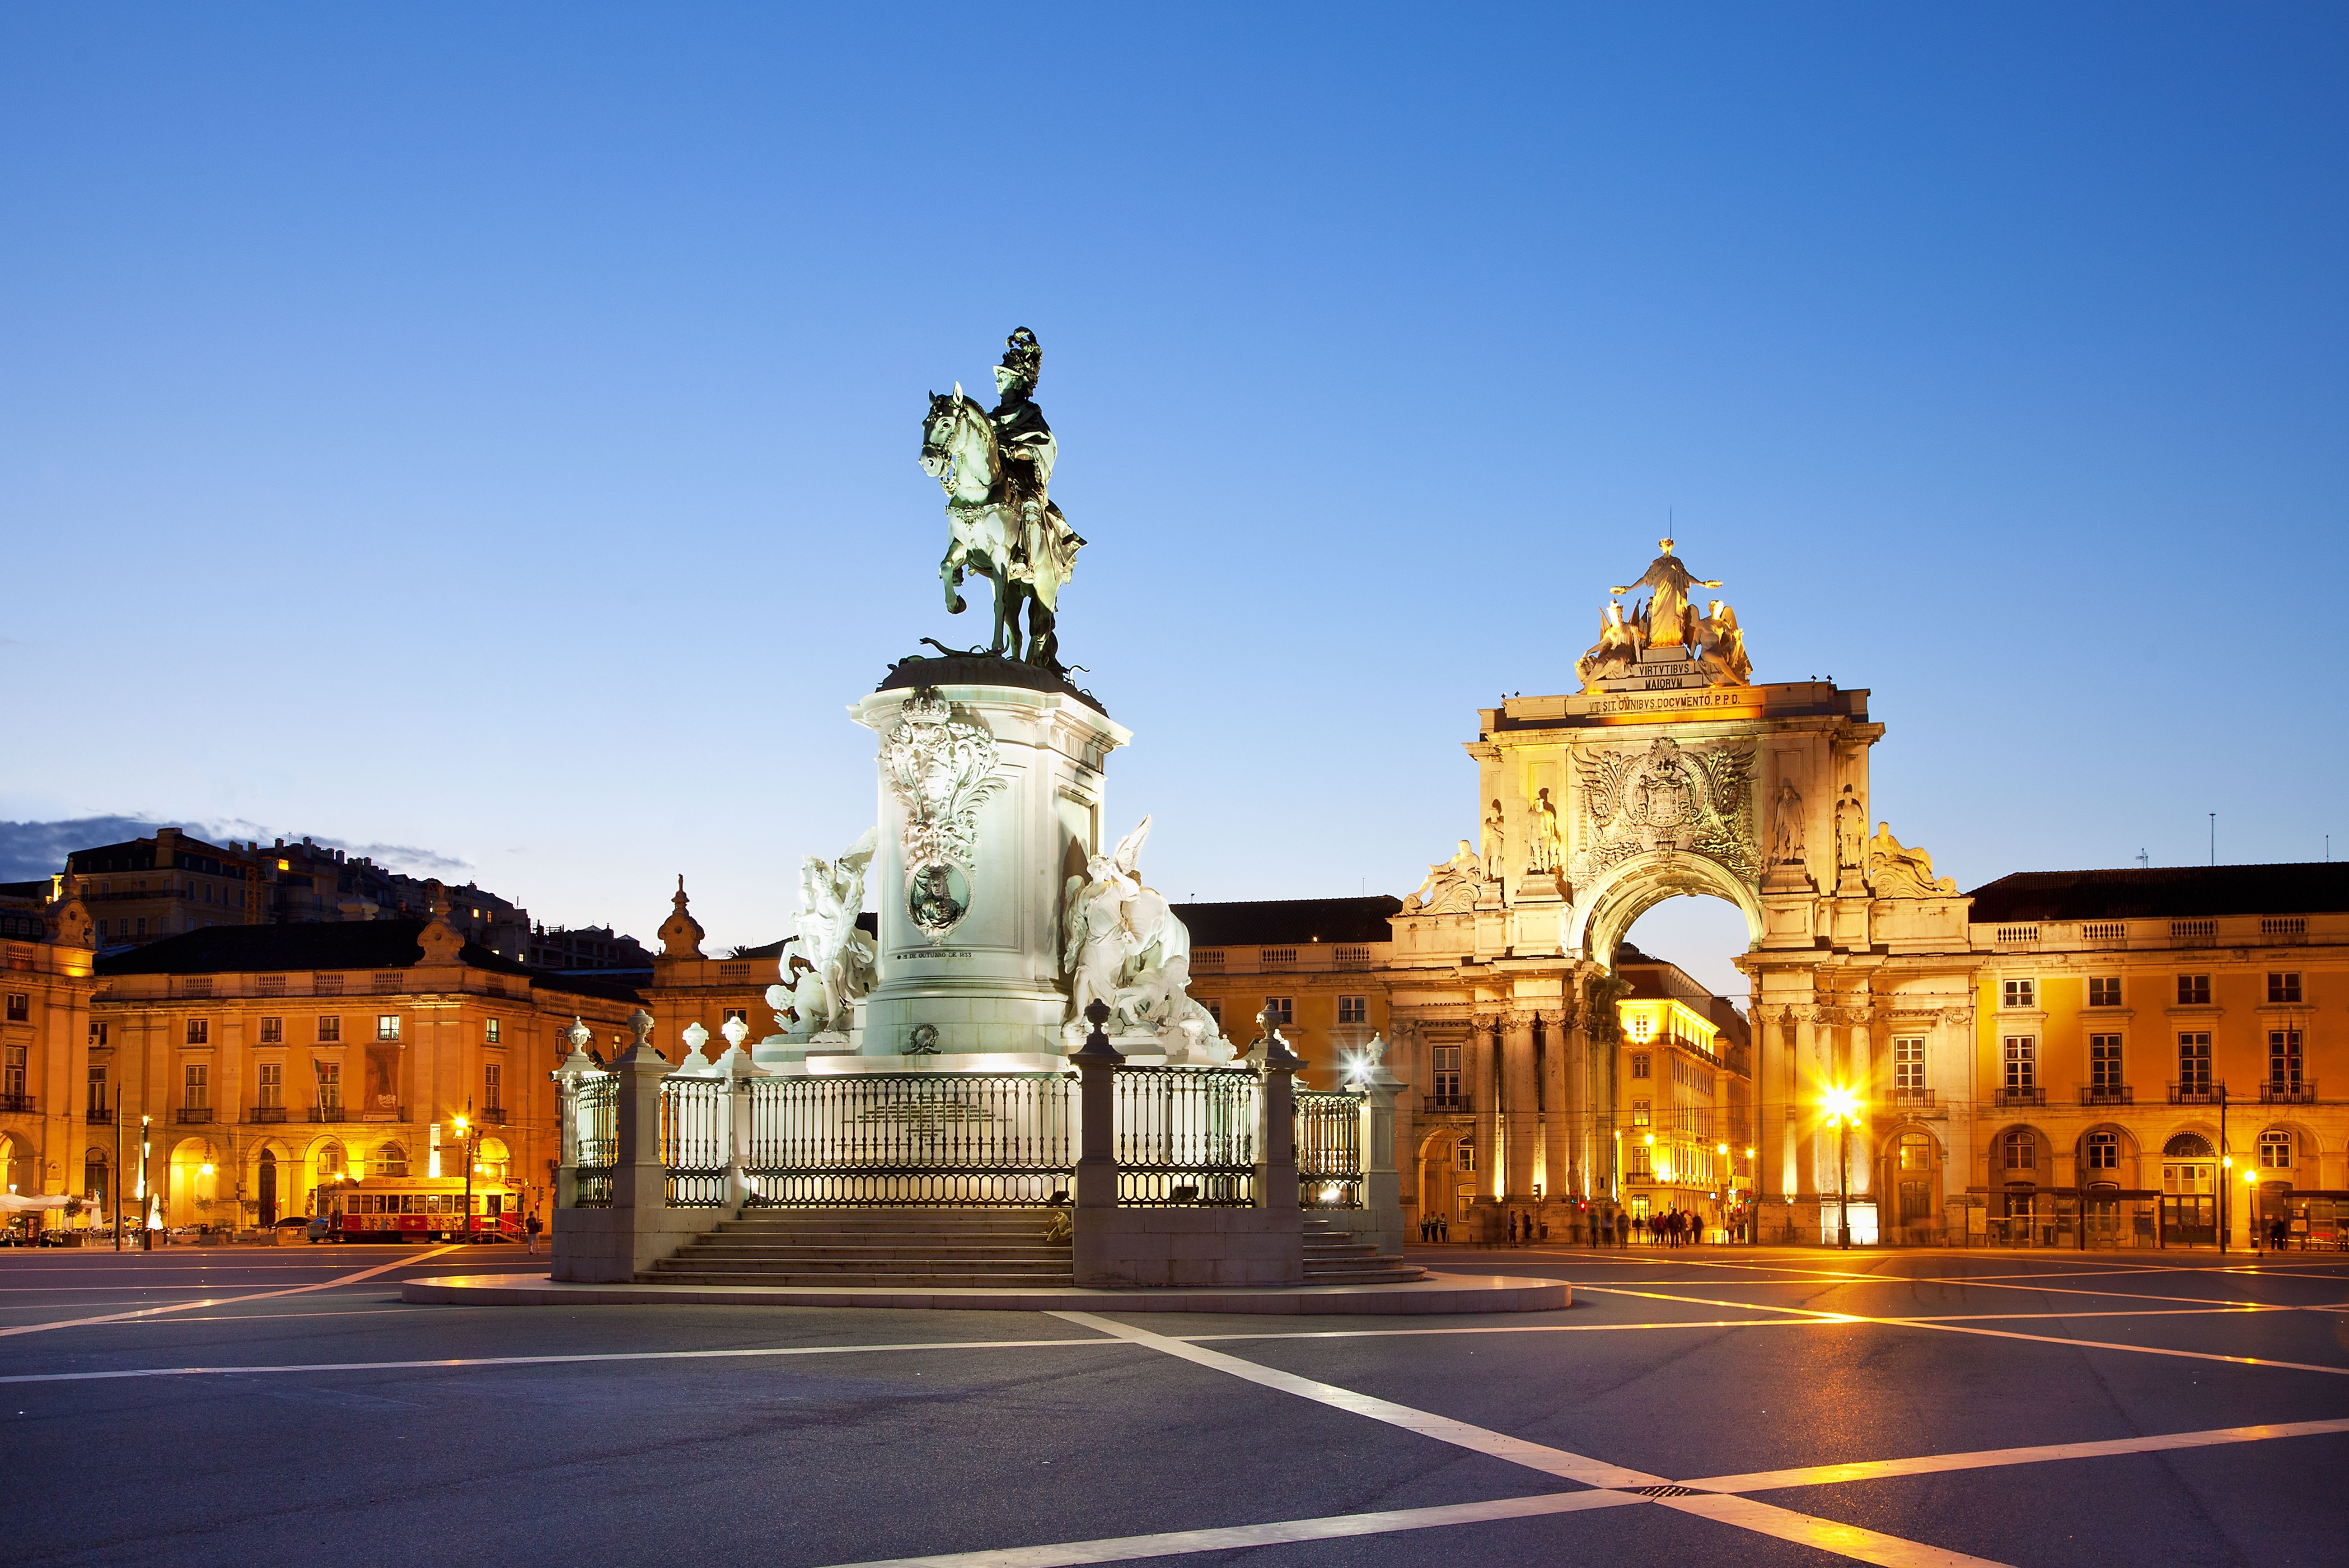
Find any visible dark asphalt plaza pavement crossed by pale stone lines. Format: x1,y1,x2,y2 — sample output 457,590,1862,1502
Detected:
0,1246,2349,1568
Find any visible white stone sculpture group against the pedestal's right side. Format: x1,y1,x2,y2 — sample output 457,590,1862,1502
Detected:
1062,817,1231,1061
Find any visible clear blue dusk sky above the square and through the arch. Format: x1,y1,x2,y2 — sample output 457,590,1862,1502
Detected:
0,5,2349,984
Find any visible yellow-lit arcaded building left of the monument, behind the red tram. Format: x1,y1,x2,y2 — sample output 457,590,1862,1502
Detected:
0,887,636,1230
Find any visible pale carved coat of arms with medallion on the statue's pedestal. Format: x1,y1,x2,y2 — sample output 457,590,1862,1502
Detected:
881,690,1003,941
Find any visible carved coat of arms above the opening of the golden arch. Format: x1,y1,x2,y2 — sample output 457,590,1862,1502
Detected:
1572,739,1757,882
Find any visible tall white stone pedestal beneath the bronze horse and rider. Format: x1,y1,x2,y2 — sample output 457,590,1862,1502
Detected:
855,657,1132,1073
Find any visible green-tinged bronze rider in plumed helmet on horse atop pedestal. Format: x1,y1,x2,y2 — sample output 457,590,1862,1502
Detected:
921,326,1085,674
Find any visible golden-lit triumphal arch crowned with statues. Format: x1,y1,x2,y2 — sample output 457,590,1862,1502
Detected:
1388,540,1975,1239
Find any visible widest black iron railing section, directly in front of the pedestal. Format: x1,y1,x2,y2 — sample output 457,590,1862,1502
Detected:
742,1073,1076,1209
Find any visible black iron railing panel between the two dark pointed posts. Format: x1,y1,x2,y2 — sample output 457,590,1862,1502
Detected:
1111,1068,1264,1209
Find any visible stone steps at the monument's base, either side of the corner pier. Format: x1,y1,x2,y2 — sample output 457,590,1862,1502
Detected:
639,1209,1428,1288
